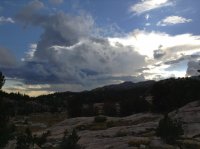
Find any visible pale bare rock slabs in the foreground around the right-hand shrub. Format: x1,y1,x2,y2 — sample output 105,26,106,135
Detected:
41,102,200,149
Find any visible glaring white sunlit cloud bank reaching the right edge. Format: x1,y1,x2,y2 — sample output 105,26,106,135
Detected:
109,30,200,59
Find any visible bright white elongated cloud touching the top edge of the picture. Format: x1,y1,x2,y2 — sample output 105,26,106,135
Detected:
130,0,172,15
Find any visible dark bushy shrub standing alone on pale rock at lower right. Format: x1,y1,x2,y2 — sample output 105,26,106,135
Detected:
156,115,184,144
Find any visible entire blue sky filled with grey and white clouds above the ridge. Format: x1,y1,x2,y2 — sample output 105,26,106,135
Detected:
0,0,200,96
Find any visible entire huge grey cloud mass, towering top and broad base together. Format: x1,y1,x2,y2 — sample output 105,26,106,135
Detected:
4,12,145,88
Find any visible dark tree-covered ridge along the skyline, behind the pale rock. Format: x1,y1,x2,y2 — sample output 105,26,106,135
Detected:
0,77,200,117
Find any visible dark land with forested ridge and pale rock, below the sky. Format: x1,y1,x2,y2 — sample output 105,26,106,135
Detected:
0,77,200,149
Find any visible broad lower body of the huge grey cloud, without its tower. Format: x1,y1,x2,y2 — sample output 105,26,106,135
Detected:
14,39,144,85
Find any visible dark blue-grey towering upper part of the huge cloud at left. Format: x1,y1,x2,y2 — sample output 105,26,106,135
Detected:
33,13,94,57
